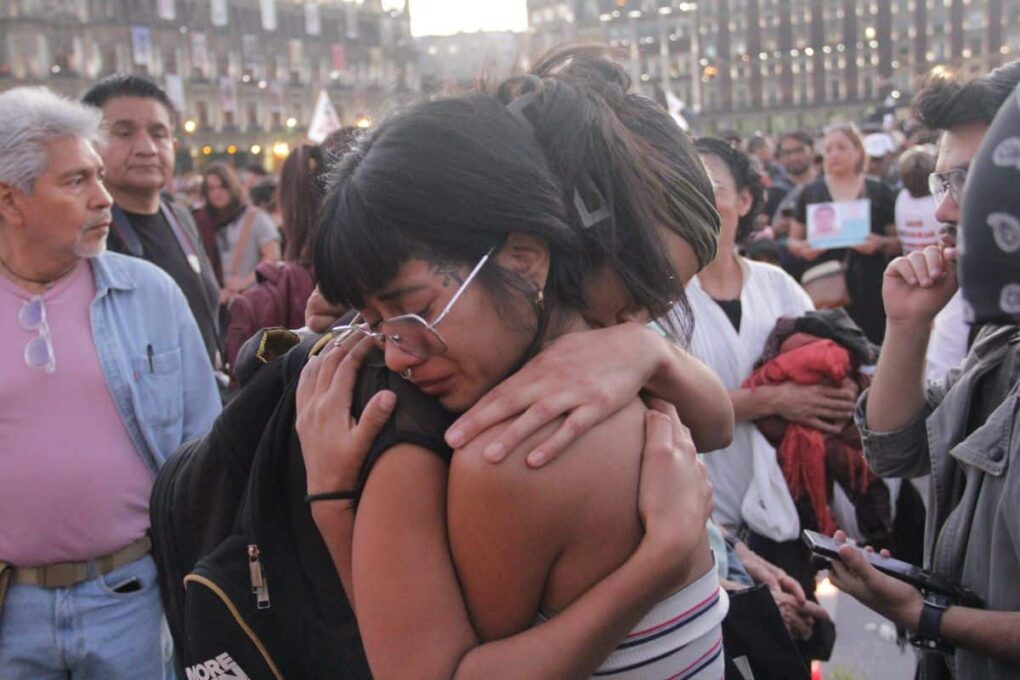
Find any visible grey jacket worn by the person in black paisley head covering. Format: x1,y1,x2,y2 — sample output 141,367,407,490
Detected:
855,326,1020,680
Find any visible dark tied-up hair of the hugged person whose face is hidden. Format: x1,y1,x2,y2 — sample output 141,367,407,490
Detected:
497,45,719,343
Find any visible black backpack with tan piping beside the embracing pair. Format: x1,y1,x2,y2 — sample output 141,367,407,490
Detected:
149,331,371,680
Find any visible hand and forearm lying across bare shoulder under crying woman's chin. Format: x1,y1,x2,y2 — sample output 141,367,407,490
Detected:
447,322,733,467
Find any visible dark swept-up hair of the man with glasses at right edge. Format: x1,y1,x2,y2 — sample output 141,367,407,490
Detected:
913,59,1020,130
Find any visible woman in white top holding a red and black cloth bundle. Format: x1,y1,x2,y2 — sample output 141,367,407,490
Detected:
687,139,856,592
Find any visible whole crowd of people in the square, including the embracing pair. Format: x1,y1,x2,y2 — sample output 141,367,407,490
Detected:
0,47,1020,680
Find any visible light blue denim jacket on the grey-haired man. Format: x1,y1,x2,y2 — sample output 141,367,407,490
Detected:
90,252,220,475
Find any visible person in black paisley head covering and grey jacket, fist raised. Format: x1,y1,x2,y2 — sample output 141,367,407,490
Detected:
833,82,1020,680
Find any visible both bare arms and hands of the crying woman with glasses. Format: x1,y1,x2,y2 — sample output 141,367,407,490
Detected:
297,339,711,678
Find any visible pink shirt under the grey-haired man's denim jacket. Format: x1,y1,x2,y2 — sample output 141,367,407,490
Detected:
0,262,153,566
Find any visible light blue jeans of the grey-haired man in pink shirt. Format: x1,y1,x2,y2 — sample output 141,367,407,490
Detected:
0,556,173,680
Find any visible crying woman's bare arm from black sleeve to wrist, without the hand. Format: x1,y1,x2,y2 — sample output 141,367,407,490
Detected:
354,444,693,680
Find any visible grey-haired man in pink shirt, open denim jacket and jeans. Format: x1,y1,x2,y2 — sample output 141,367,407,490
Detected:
0,88,219,680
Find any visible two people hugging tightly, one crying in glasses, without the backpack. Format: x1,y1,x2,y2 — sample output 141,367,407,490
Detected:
297,48,732,678
